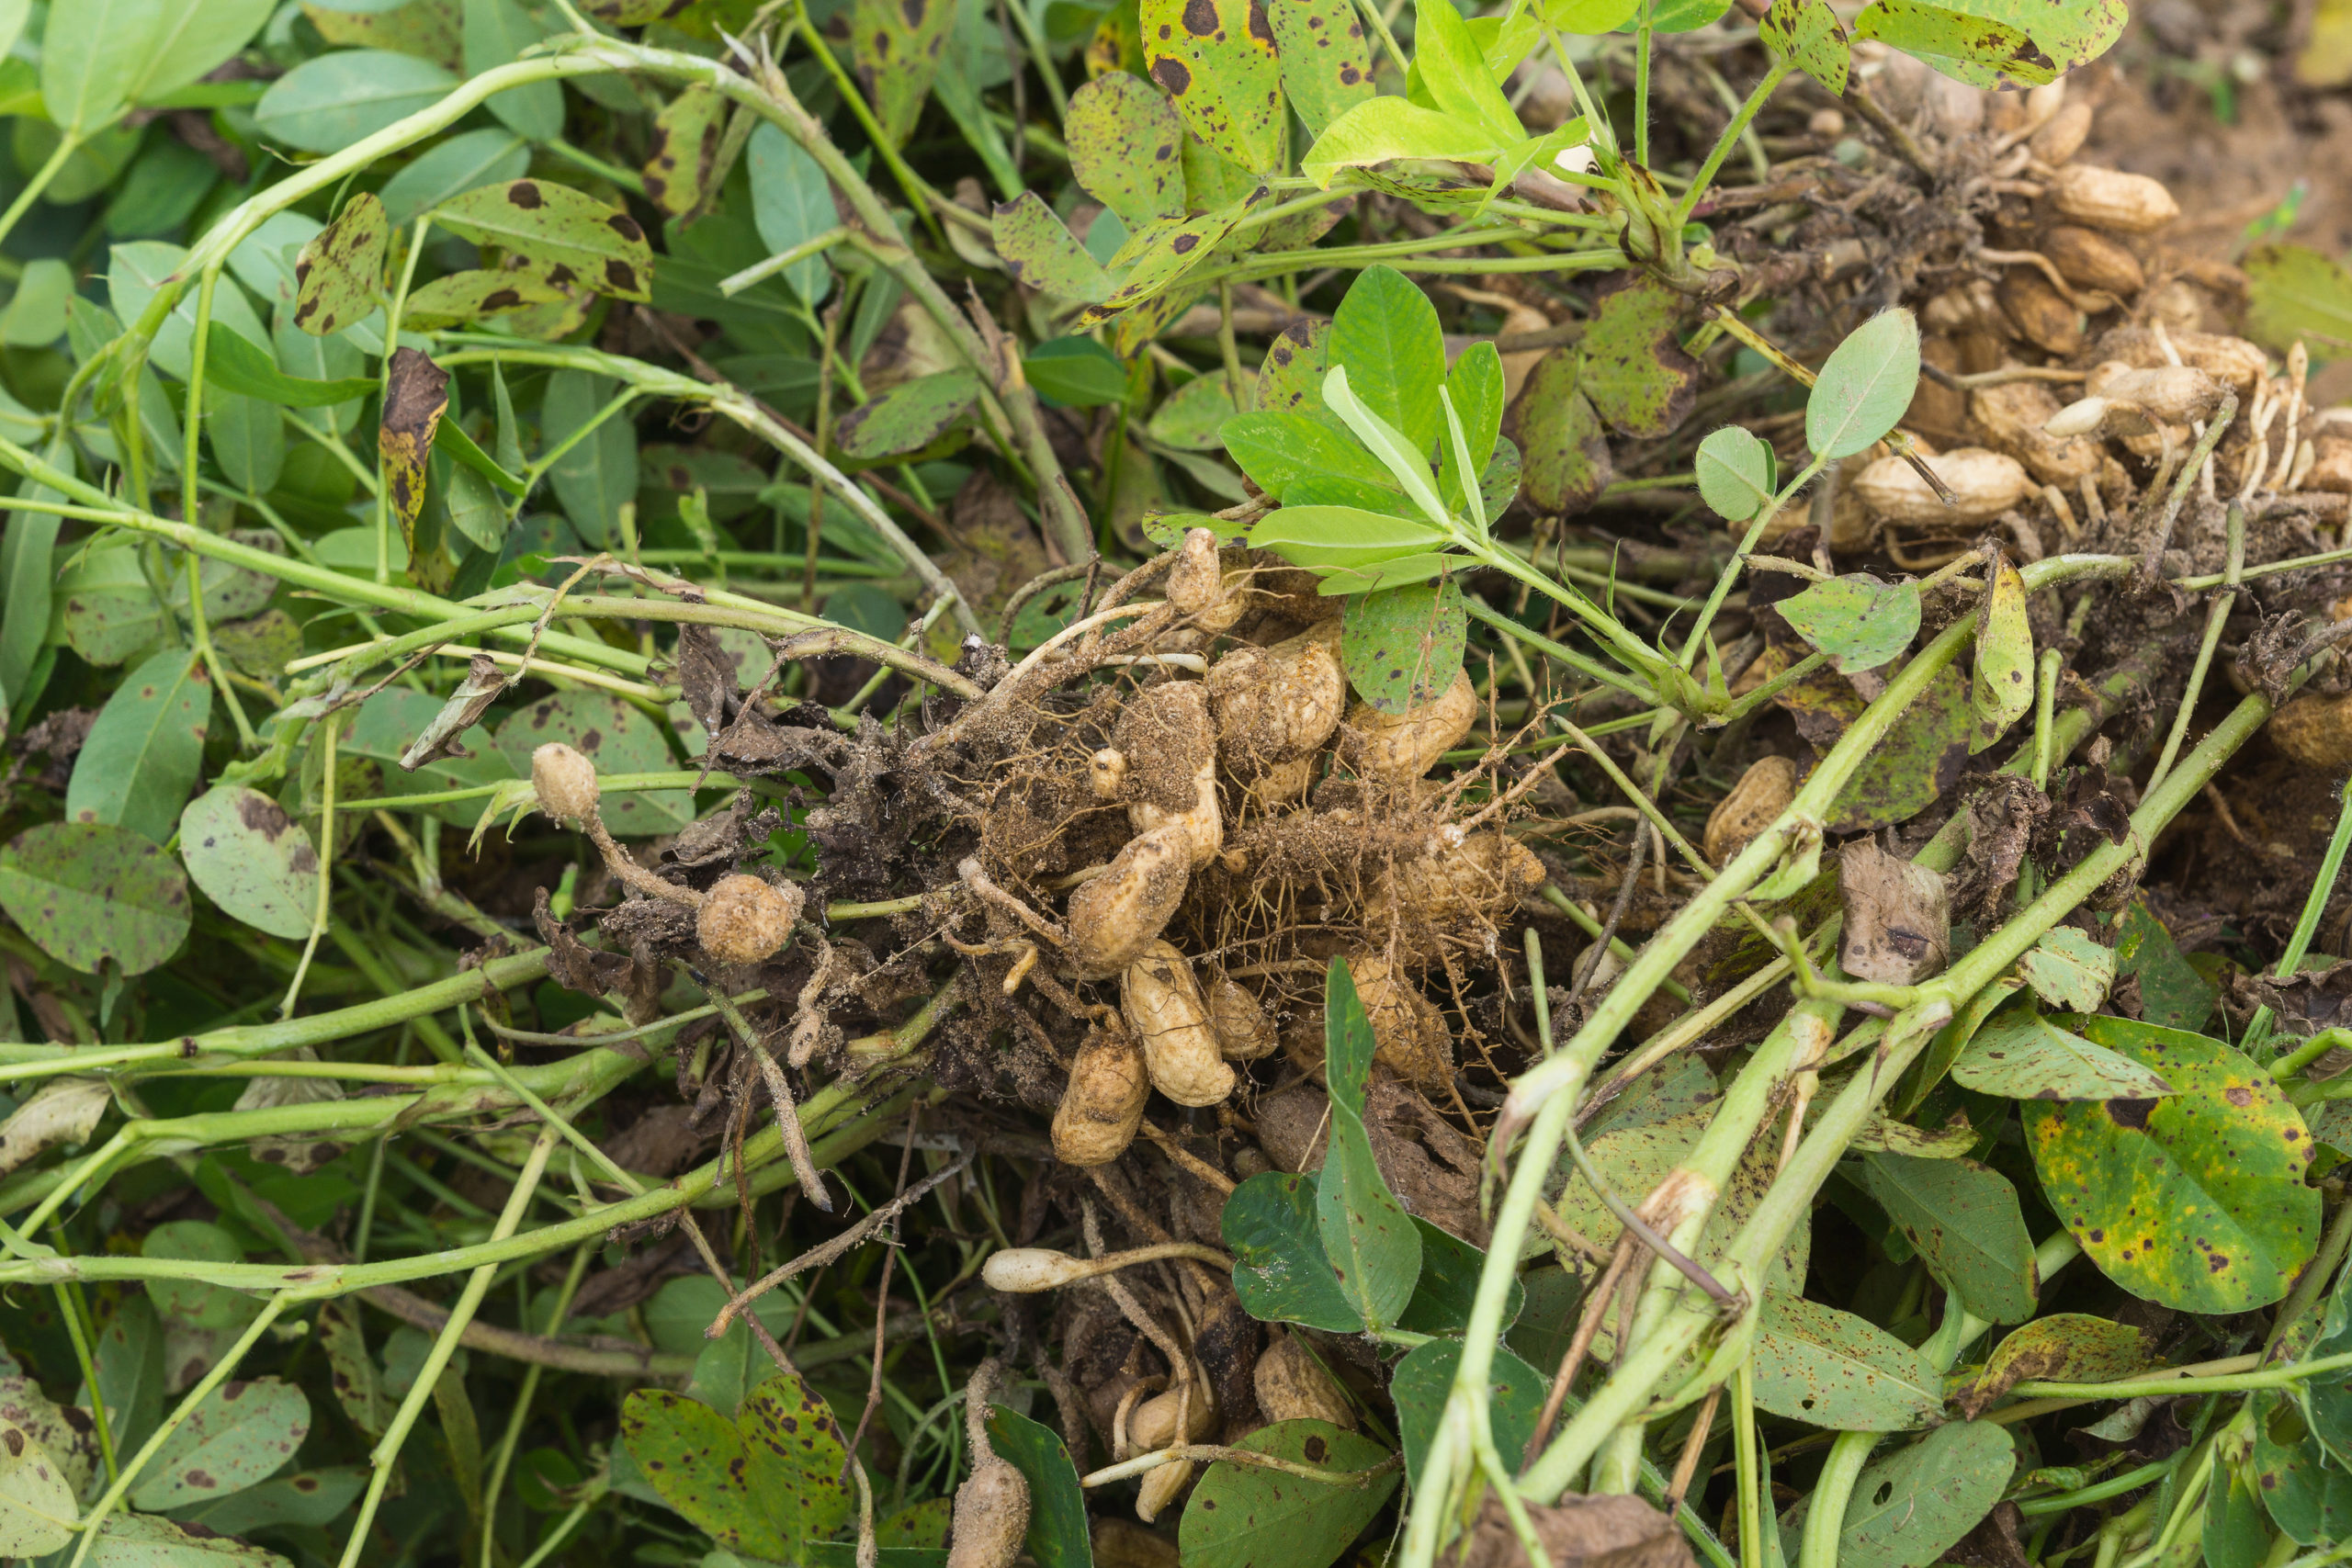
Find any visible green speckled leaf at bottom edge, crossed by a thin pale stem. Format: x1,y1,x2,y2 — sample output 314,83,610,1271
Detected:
1176,1420,1397,1568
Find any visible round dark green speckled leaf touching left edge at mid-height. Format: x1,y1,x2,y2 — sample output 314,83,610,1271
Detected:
0,823,188,976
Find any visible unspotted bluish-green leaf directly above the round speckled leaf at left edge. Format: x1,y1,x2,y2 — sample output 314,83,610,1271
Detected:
66,649,211,844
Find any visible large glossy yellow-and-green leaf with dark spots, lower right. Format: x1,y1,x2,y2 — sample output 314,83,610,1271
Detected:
2020,1016,2319,1314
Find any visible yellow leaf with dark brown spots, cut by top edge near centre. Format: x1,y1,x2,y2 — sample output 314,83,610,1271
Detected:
1141,0,1286,174
